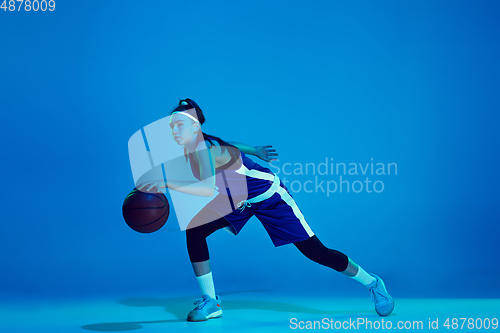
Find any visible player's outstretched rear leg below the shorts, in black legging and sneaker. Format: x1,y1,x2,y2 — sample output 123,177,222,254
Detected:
294,235,394,316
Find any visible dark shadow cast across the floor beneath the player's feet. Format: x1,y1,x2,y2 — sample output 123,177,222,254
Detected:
82,289,374,332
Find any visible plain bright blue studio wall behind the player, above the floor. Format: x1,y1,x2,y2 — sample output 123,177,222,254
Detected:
0,0,500,298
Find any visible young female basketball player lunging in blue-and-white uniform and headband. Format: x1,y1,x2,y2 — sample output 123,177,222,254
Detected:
138,98,394,321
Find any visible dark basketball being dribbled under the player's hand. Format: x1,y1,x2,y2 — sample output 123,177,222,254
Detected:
122,188,170,233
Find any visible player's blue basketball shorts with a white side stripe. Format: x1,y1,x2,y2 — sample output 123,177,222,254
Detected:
204,181,314,246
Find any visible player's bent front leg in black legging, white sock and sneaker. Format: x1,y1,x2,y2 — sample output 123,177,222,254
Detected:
186,212,230,321
